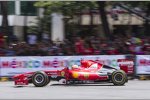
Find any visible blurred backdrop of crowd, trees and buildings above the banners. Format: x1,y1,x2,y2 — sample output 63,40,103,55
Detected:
0,0,150,56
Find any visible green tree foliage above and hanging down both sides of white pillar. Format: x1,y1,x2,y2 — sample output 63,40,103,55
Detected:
28,1,97,36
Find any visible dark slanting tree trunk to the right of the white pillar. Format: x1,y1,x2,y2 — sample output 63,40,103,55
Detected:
97,1,111,39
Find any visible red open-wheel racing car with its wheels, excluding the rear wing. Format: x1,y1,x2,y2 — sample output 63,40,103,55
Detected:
14,60,128,87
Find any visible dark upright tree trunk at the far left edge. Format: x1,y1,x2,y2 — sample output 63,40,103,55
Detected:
0,1,9,42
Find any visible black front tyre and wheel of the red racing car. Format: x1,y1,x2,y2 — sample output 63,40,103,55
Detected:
32,71,50,87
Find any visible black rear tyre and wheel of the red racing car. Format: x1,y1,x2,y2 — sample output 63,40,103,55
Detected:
111,70,127,85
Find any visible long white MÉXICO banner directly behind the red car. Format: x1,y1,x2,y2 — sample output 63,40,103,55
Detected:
0,55,125,76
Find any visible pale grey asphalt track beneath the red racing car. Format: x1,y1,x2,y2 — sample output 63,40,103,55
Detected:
0,80,150,99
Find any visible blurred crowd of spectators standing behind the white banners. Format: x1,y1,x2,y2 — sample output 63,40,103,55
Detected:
0,36,150,56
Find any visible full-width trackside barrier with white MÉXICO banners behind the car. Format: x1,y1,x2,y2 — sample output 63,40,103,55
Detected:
0,55,150,81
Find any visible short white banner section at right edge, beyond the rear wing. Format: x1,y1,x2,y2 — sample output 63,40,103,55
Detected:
136,55,150,74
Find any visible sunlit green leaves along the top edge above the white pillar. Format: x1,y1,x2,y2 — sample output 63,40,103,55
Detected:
35,1,97,16
